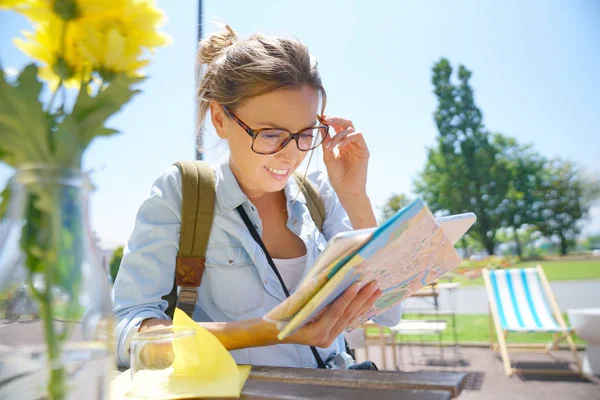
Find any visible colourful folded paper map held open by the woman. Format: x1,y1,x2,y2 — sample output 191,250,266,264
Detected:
264,198,475,340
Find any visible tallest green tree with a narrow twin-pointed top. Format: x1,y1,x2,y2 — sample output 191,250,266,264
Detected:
415,58,510,255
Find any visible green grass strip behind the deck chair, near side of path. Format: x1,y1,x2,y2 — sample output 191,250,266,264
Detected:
368,314,584,343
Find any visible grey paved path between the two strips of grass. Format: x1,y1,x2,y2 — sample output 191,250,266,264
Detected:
405,280,600,314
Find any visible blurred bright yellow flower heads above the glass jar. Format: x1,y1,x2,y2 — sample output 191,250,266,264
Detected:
12,0,169,89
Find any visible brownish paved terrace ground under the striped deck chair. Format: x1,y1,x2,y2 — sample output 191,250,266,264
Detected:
356,346,600,400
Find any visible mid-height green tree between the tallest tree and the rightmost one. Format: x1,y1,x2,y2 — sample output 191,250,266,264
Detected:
493,134,546,257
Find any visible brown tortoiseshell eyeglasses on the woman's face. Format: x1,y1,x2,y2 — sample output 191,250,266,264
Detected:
222,106,329,155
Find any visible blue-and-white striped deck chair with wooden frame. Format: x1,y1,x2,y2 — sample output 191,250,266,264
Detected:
483,265,582,376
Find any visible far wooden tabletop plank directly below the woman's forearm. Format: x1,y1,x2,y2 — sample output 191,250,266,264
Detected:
250,366,467,397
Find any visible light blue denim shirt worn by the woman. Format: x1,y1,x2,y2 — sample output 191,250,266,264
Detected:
112,162,401,367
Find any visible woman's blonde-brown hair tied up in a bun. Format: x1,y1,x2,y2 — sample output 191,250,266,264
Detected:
196,25,327,150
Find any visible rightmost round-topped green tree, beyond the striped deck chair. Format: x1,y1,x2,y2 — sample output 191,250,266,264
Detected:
538,159,589,255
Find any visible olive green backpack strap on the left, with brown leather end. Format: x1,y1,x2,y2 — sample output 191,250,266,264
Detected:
165,161,216,318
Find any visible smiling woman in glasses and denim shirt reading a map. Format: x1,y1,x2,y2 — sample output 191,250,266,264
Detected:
113,26,401,367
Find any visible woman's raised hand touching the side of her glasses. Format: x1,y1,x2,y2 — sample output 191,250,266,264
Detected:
323,117,369,197
